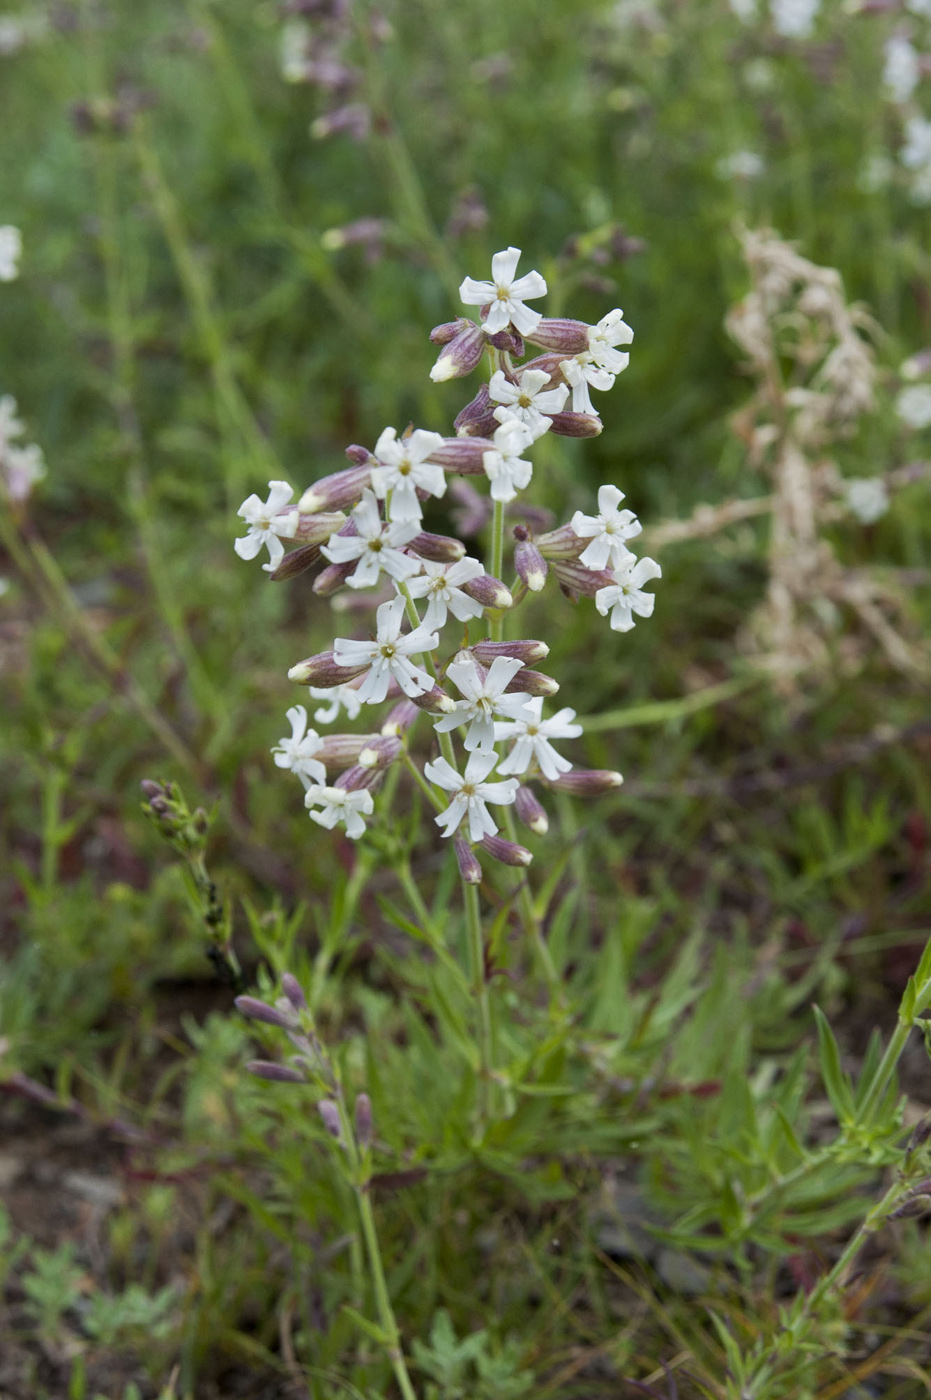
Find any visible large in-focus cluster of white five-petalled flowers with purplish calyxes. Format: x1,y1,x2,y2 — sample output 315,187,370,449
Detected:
235,248,659,862
